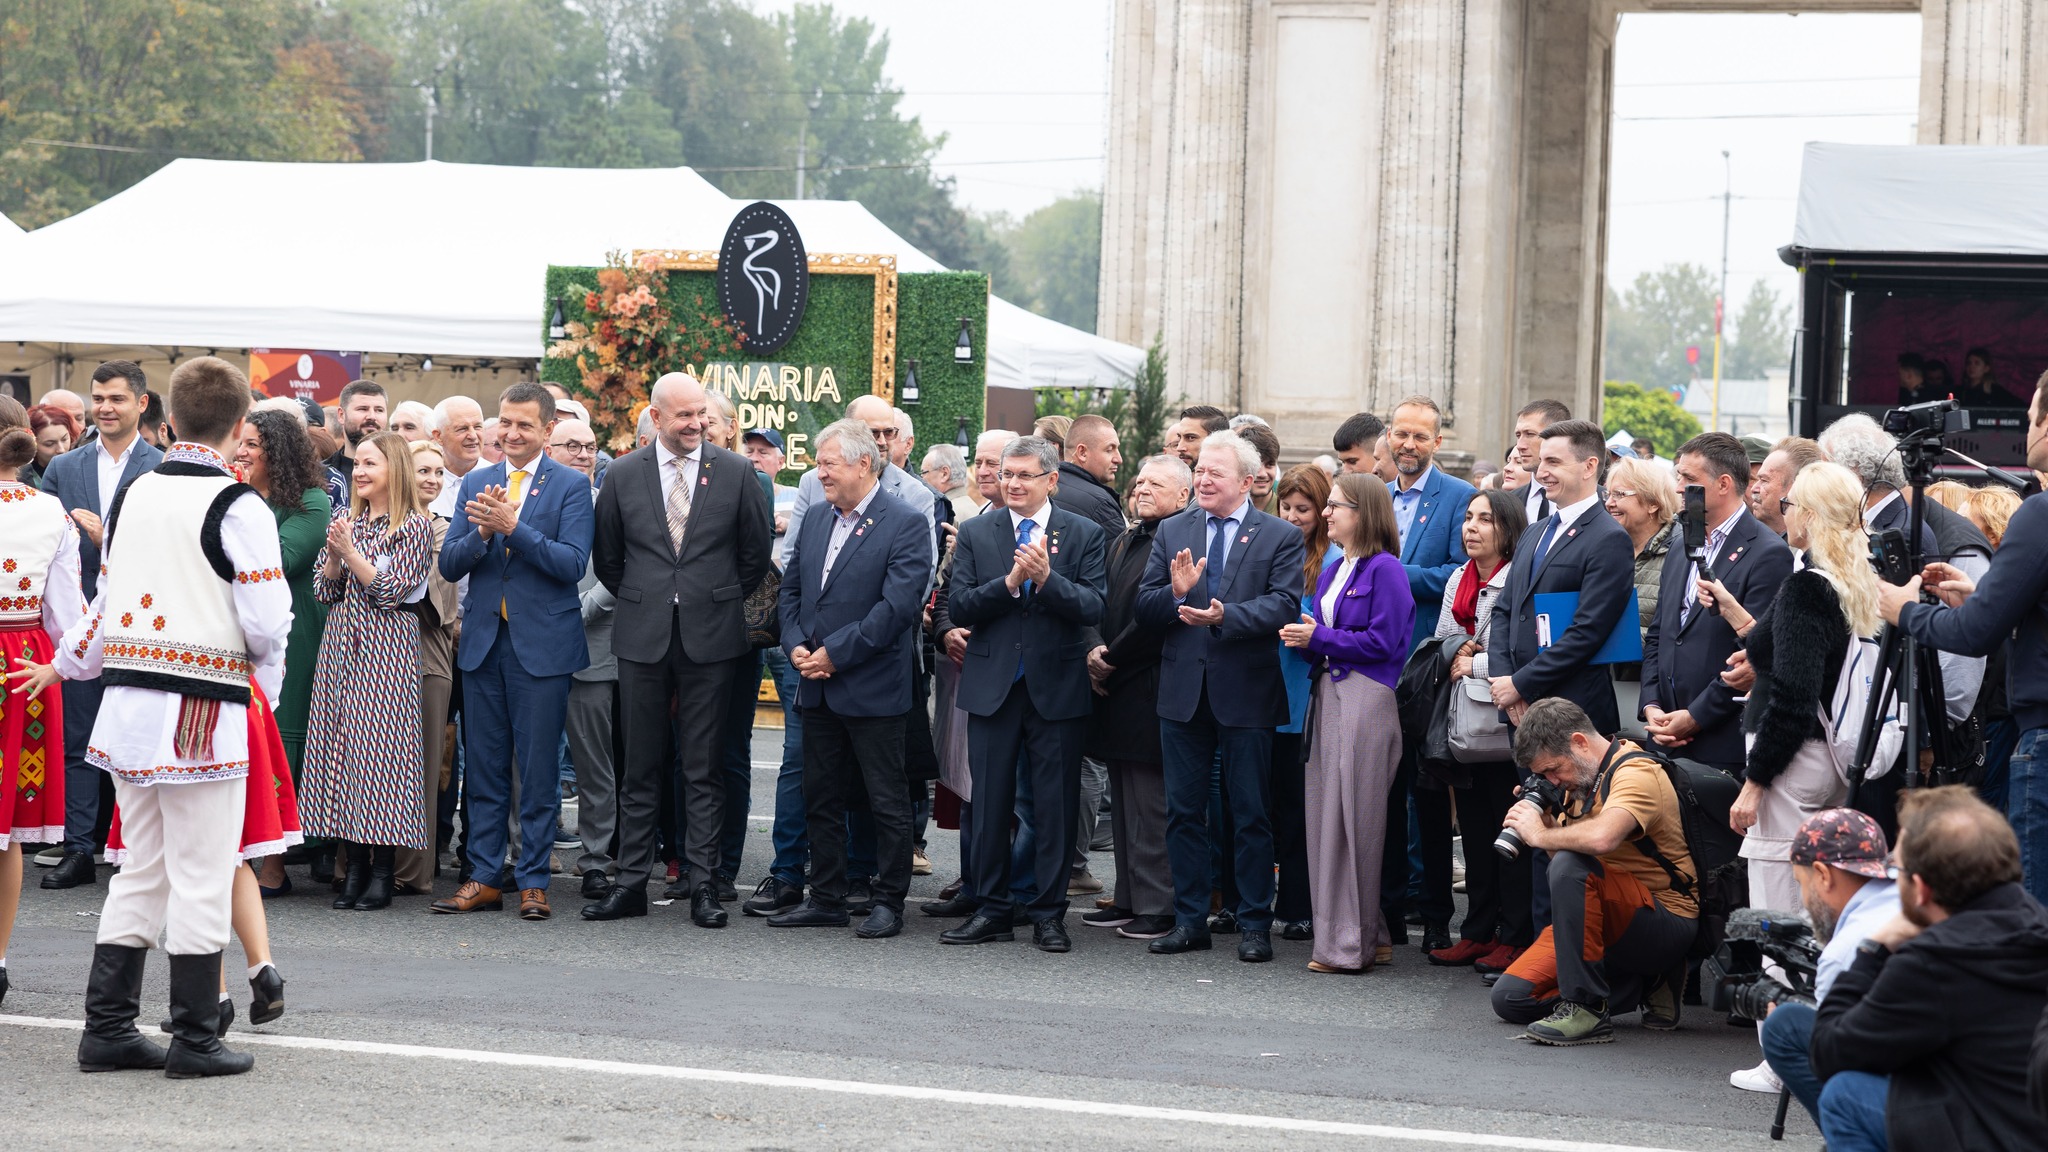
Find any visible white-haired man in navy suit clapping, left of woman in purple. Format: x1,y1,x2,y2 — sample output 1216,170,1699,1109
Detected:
1137,433,1305,961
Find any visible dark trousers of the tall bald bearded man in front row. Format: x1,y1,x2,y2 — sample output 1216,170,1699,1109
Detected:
618,613,735,886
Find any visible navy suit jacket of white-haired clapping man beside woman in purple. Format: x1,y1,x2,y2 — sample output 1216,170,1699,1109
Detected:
1137,504,1307,728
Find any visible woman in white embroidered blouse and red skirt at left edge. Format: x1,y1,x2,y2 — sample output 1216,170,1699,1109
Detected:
0,396,86,998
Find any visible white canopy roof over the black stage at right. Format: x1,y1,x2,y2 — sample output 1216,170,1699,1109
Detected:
1792,143,2048,256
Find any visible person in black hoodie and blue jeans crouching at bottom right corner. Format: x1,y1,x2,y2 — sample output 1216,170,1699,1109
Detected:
1810,785,2048,1152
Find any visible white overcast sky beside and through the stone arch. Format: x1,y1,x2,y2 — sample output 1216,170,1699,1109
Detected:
762,0,1919,315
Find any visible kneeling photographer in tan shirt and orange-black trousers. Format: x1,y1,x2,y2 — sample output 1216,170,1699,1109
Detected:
1493,697,1700,1047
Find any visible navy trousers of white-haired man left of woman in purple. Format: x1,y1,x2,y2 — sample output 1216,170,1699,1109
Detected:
1159,699,1274,933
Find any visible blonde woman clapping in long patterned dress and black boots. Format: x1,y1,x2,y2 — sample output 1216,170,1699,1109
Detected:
299,433,434,912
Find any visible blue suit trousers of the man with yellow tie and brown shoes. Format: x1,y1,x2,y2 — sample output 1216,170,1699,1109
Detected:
463,627,569,888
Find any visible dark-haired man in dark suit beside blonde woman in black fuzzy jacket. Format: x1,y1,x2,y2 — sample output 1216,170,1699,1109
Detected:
1642,433,1792,775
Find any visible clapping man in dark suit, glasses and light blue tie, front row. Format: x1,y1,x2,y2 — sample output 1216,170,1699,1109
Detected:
937,437,1104,951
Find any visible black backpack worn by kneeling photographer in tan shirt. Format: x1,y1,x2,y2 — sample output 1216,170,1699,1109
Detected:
1599,748,1749,959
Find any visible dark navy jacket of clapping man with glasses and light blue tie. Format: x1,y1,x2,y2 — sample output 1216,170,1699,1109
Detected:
946,502,1108,719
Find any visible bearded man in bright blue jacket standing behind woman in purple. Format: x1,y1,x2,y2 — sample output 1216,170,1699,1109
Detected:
1380,396,1473,951
